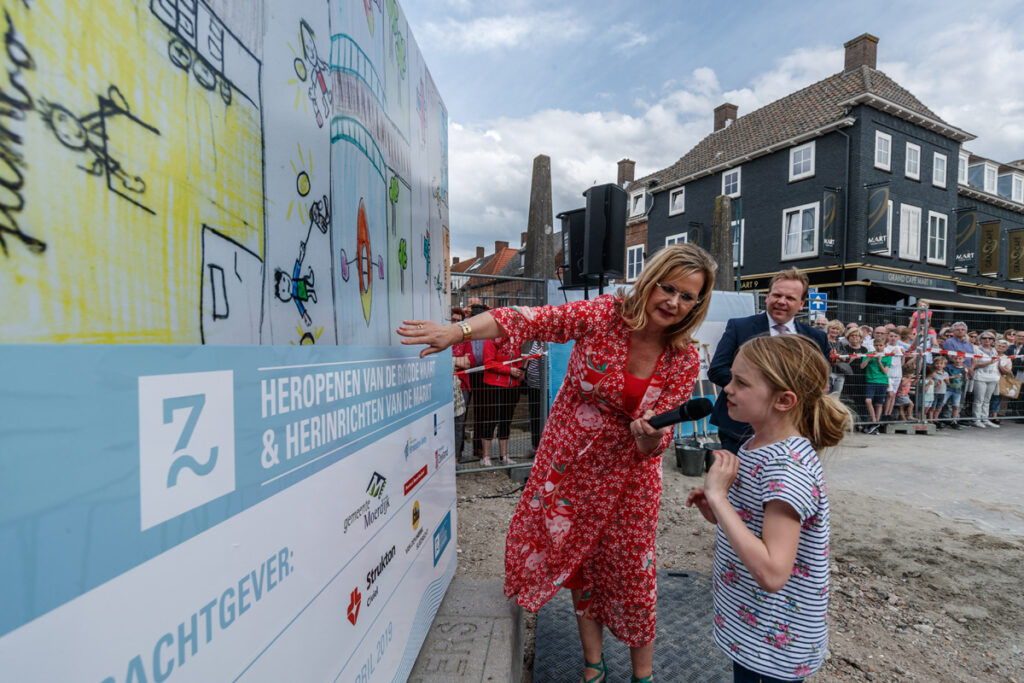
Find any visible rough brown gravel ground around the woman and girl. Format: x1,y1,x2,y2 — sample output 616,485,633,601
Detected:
457,425,1024,683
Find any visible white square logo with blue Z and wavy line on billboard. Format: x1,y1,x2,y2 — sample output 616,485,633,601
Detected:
138,371,234,529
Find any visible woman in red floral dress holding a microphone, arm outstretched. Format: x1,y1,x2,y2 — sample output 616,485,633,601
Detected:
398,244,716,683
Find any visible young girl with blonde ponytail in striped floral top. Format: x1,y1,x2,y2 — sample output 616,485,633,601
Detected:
686,335,852,683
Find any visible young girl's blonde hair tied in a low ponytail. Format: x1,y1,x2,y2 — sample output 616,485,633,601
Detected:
738,335,853,451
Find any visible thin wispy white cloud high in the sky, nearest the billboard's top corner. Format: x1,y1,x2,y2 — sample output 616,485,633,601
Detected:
417,11,587,52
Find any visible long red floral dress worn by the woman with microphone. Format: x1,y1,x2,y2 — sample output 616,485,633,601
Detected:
490,295,699,647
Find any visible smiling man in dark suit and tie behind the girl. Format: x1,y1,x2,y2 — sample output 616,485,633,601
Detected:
708,268,829,453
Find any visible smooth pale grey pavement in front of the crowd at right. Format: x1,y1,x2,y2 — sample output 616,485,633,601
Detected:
822,420,1024,537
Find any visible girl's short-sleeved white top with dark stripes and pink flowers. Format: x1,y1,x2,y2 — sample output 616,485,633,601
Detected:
714,436,828,680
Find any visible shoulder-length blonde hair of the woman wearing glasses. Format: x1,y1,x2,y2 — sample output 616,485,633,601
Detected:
615,244,718,348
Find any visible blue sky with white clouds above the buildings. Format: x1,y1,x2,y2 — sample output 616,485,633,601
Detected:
401,0,1024,258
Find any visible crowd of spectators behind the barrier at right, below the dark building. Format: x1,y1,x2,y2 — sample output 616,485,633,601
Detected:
814,304,1024,434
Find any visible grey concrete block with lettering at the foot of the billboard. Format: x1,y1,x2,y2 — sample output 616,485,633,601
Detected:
409,577,525,683
